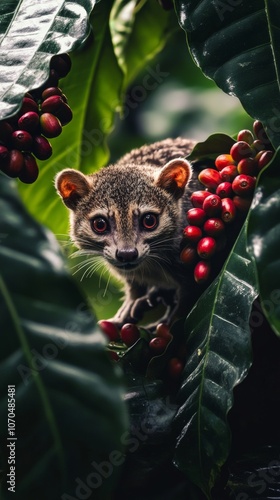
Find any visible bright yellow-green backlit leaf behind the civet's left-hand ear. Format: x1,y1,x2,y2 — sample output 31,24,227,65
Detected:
19,0,123,235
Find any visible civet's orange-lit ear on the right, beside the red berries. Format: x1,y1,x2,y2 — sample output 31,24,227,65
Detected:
156,158,192,199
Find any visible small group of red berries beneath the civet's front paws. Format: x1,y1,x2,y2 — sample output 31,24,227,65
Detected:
98,320,185,381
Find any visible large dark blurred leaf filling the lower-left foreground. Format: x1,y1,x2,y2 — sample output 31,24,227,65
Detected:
0,174,127,500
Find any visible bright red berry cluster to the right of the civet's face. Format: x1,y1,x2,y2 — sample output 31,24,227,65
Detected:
180,120,274,283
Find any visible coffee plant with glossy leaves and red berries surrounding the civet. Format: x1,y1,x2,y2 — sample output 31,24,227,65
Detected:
0,0,280,500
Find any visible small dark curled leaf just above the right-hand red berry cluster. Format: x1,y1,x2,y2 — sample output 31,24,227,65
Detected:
187,134,235,161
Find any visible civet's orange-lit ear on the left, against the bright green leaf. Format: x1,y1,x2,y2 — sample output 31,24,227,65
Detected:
55,168,90,210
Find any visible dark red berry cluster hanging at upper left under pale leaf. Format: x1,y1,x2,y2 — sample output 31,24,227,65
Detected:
0,54,72,183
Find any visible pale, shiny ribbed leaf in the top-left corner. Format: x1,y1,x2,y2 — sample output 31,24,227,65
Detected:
0,0,95,120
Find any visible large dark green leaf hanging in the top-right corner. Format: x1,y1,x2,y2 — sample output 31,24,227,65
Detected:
175,0,280,146
